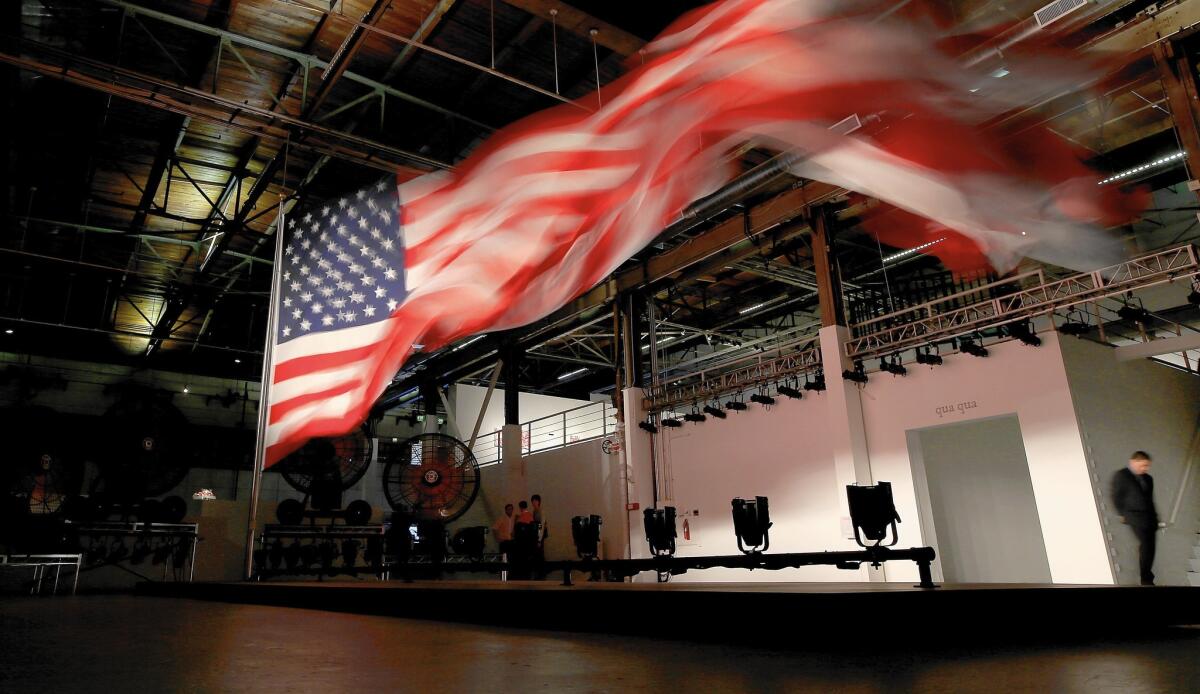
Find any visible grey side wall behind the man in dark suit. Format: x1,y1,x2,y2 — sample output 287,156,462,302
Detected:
1063,337,1200,585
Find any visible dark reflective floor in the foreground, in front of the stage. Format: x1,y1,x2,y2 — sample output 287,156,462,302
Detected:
0,596,1200,694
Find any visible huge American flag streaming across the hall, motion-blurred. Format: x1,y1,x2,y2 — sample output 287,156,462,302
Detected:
266,0,1118,465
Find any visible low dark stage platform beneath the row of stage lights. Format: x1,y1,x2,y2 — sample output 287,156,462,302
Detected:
138,580,1200,633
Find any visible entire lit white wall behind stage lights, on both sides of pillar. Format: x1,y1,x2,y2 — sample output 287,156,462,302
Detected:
648,333,1112,584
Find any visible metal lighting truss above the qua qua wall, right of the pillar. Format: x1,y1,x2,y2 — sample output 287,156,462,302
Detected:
845,244,1200,359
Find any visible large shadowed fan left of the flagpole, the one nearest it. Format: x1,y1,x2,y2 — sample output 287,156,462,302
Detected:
98,388,192,507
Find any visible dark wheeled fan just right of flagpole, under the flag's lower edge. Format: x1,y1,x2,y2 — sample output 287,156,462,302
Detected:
276,430,371,525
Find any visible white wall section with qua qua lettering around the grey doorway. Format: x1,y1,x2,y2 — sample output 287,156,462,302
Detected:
863,333,1112,584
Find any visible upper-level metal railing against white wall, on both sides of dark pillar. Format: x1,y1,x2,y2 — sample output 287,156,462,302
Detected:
472,401,617,466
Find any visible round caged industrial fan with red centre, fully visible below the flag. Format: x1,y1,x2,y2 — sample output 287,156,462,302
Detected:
383,433,479,524
